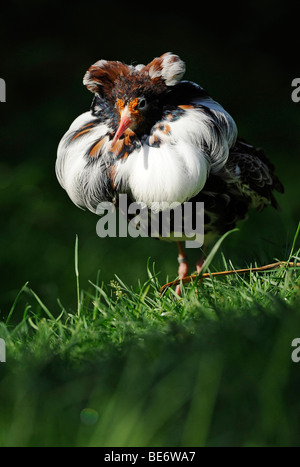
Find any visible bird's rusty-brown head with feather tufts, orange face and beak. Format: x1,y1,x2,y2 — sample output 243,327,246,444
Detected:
83,52,185,144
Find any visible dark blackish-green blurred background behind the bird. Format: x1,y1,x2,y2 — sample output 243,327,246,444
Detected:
0,1,300,319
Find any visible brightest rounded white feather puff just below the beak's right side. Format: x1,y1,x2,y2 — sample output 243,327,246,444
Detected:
115,141,208,208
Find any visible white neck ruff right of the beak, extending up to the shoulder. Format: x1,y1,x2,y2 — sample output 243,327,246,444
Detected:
115,100,236,206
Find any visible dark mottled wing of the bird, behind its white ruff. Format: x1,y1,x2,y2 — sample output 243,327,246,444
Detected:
191,139,283,235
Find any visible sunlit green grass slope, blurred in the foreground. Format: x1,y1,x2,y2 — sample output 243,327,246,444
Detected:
0,229,300,447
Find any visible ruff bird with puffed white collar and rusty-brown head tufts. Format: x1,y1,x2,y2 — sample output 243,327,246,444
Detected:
56,52,284,295
